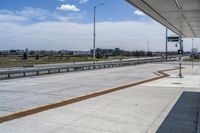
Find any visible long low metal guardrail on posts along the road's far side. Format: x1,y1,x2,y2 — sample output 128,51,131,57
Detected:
0,58,173,79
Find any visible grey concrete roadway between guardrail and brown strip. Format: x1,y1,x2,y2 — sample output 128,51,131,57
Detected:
0,64,175,116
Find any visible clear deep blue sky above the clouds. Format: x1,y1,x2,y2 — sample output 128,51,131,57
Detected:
0,0,148,23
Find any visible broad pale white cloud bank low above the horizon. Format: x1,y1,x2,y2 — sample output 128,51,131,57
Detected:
0,21,168,50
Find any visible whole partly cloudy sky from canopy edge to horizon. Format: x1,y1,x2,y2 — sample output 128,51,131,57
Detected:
0,0,200,51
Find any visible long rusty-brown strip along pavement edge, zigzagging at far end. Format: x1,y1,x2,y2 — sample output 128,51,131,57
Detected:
0,68,177,123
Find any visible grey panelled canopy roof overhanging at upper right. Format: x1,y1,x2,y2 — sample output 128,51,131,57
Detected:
127,0,200,38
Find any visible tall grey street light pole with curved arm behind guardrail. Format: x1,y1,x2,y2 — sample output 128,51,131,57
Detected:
93,3,105,63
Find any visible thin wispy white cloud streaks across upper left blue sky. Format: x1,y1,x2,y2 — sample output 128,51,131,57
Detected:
0,7,84,24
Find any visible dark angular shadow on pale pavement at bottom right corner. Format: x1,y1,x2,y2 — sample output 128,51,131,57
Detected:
156,92,200,133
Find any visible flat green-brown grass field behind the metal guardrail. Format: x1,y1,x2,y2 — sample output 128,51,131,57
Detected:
0,55,134,68
